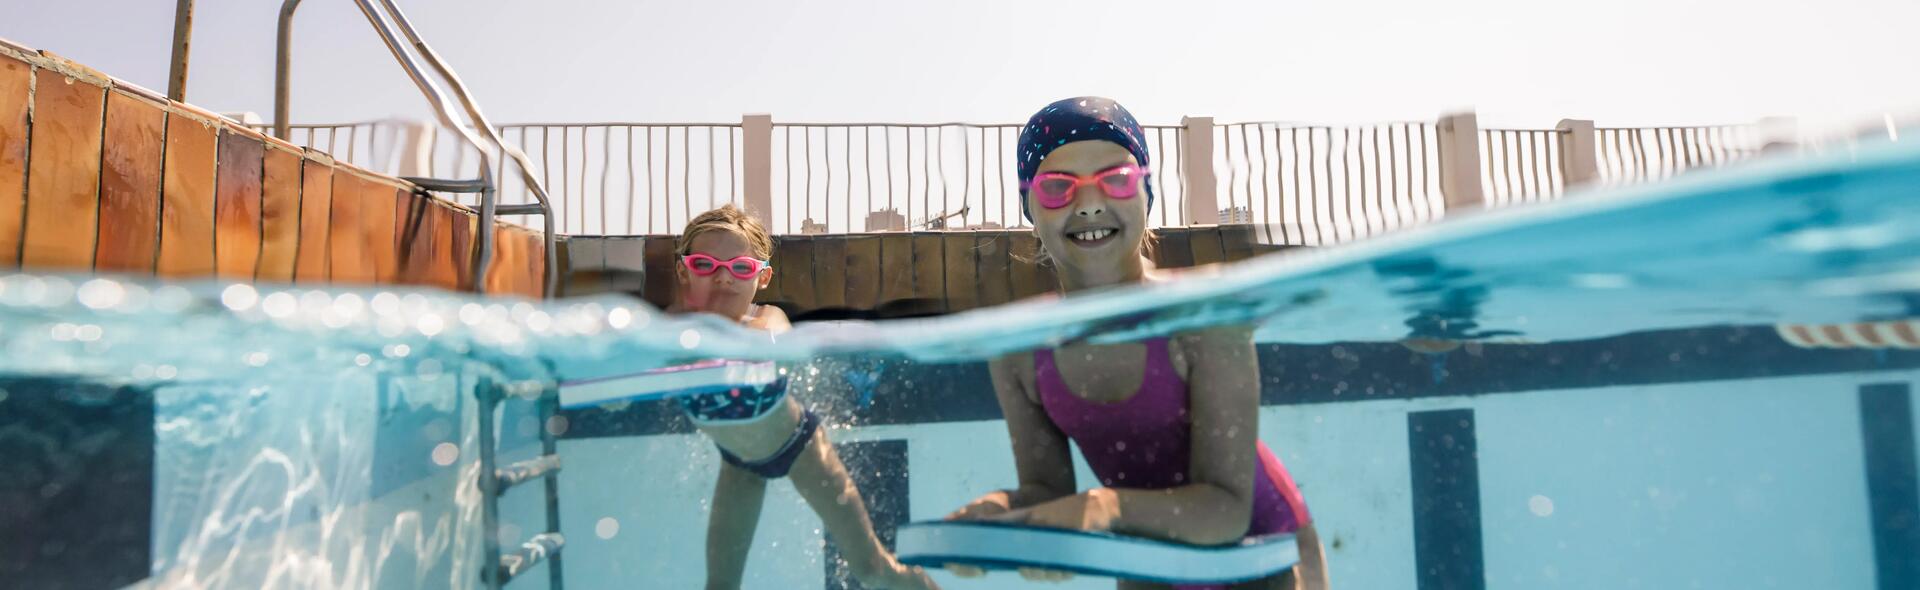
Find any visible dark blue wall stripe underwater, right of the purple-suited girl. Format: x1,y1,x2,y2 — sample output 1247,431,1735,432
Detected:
1407,409,1486,590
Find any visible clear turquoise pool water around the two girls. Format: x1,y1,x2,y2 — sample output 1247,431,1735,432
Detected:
0,136,1920,588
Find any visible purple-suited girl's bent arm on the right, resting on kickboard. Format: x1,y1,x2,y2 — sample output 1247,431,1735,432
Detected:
1006,327,1260,544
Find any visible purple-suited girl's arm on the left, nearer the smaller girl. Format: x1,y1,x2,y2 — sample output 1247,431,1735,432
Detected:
952,356,1075,519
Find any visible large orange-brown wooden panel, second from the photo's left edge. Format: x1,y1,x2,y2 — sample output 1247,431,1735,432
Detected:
21,69,108,269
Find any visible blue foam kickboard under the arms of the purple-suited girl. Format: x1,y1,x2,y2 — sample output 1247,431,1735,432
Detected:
895,521,1300,584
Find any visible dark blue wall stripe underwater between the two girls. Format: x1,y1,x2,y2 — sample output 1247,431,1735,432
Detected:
822,440,912,590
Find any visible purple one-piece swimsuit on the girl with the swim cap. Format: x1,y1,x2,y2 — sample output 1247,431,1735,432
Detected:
1033,338,1311,588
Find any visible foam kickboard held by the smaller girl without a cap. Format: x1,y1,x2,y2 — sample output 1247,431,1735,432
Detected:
561,359,780,409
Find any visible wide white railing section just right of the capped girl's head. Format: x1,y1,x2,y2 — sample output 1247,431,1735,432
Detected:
1194,123,1446,246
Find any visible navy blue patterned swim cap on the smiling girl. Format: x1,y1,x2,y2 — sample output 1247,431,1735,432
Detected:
1014,96,1154,221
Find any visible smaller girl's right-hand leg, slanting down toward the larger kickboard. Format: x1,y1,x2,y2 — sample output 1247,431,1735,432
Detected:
787,418,935,588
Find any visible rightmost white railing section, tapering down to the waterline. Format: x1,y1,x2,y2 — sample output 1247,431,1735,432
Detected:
1594,125,1764,184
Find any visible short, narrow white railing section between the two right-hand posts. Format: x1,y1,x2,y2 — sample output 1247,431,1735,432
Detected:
1480,129,1567,208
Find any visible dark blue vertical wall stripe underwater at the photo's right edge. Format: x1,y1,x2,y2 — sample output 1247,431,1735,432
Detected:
1860,382,1920,590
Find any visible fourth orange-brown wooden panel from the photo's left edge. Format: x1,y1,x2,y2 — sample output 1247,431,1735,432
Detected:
156,111,219,277
